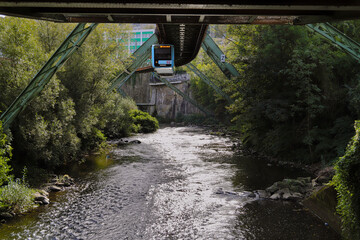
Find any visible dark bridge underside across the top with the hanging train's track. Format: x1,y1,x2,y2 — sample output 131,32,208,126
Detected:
0,0,360,66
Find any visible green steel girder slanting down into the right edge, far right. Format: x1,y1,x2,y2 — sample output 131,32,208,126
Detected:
306,23,360,62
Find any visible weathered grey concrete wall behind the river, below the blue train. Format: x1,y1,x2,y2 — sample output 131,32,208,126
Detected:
122,73,202,119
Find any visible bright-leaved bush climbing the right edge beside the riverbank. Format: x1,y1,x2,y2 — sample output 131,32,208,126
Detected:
334,121,360,239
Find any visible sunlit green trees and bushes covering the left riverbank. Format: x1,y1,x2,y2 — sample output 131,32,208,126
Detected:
0,17,158,218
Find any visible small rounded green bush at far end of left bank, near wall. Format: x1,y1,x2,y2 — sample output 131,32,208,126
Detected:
130,110,159,133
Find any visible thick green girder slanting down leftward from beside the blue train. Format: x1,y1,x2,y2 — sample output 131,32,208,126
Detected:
108,34,158,92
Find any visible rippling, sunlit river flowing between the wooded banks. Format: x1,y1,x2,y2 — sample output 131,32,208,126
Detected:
0,127,339,240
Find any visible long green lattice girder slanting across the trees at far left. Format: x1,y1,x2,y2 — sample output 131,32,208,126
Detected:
0,23,97,129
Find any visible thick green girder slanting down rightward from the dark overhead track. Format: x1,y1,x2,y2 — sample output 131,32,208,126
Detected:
201,34,240,79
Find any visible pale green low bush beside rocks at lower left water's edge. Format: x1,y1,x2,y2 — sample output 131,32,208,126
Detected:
0,179,34,213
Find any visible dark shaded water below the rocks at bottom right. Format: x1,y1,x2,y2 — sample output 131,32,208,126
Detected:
234,200,340,240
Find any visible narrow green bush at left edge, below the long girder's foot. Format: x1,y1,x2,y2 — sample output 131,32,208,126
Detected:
0,122,12,186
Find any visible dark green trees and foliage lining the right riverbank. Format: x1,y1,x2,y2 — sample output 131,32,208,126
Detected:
191,21,360,239
